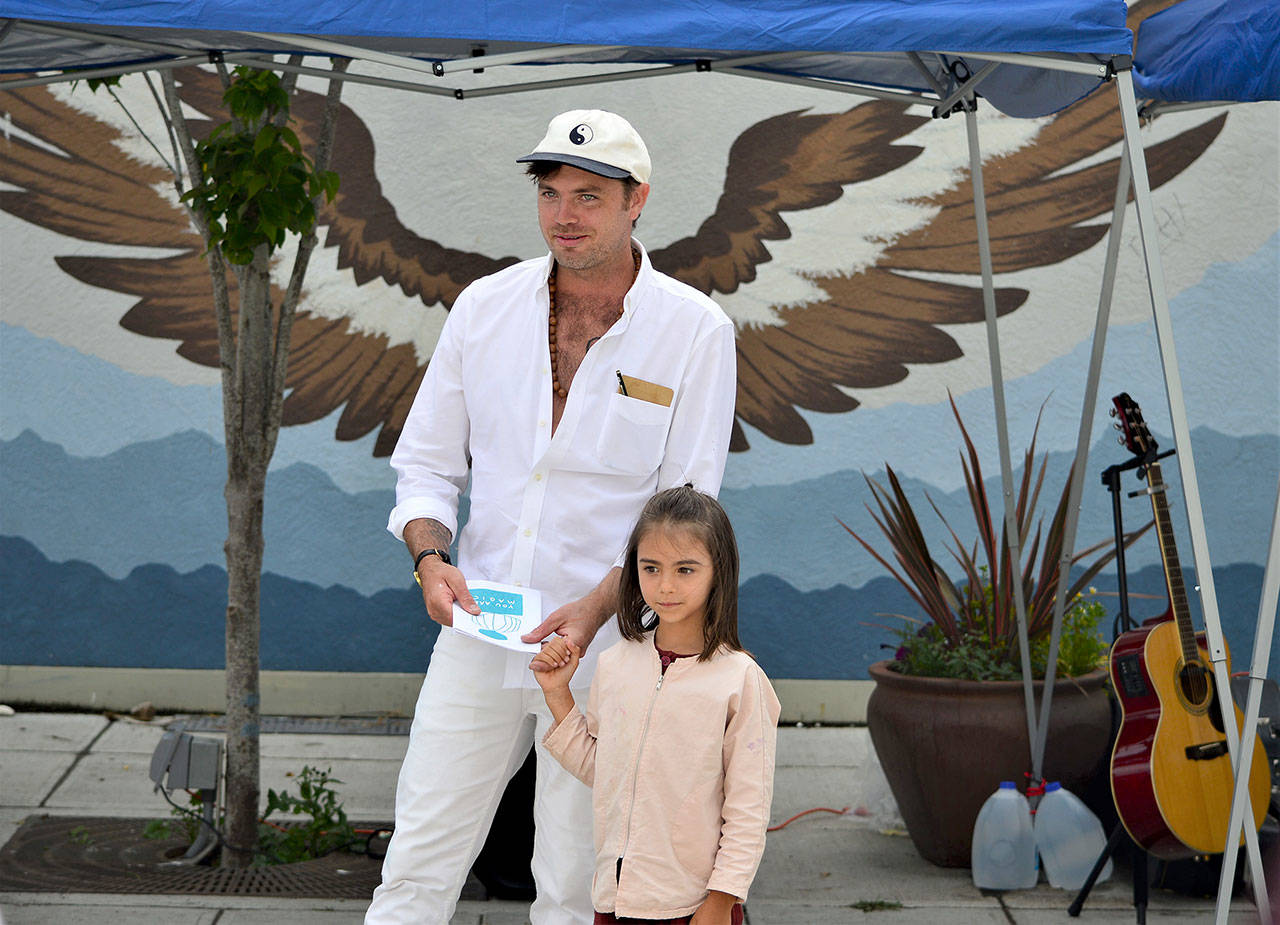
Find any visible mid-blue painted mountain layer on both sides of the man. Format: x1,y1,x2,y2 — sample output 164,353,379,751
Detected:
0,429,1280,595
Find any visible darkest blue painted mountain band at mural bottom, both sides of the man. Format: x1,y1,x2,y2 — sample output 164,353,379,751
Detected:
0,537,1262,678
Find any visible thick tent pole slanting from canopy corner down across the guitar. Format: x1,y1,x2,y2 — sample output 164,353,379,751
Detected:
1116,70,1266,925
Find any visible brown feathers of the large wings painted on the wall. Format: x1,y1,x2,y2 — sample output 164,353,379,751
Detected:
0,61,1226,455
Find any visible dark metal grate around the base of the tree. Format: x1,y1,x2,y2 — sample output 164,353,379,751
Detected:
0,816,384,899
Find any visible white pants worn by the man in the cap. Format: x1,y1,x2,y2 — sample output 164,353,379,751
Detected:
365,628,595,925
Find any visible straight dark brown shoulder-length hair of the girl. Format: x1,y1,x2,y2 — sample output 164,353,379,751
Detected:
618,485,746,661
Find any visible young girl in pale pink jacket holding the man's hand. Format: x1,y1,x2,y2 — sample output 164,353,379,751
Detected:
531,486,778,925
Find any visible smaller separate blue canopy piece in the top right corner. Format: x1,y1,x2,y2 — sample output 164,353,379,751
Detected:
1133,0,1280,102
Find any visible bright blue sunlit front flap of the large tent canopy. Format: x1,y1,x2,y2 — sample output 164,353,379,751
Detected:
0,0,1130,55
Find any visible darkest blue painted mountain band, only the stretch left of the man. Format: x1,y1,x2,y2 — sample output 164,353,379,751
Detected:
0,537,438,672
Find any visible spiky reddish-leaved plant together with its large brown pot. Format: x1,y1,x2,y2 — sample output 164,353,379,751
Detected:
841,399,1151,866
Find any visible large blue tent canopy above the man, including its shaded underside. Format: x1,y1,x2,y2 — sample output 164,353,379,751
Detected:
0,0,1133,116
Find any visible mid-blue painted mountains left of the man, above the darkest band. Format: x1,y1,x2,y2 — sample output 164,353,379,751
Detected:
0,430,399,594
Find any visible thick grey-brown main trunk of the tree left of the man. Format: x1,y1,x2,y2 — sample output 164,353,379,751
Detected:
223,246,275,867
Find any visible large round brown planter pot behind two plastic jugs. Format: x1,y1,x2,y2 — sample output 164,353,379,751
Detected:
867,661,1111,867
